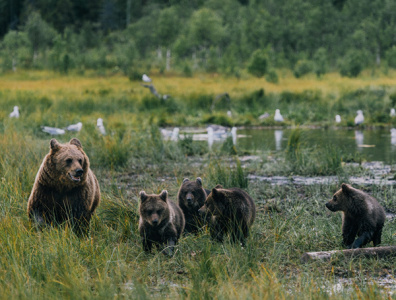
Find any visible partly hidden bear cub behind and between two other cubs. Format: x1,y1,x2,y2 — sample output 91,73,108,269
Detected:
177,177,210,233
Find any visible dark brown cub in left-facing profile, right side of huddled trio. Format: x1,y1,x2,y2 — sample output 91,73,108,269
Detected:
199,185,256,245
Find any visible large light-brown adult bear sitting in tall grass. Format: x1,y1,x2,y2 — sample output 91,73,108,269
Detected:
28,138,100,234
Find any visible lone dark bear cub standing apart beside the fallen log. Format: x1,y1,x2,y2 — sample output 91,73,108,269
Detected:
326,183,385,248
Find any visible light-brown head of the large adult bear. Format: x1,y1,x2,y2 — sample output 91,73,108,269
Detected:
47,138,89,187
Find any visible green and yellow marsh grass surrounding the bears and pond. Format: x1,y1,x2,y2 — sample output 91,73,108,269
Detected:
0,72,396,299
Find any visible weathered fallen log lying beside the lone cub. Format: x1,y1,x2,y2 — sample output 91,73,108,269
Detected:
301,246,396,262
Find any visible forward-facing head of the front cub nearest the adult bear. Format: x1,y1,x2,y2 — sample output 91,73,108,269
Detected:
139,190,170,227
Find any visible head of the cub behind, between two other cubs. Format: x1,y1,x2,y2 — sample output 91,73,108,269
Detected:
177,177,206,212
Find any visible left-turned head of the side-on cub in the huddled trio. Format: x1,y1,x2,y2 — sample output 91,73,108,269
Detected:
198,184,229,216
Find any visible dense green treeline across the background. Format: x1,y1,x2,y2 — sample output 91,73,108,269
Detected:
0,0,396,81
